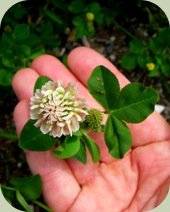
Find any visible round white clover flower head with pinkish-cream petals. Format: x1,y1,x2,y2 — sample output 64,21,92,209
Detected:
30,81,88,137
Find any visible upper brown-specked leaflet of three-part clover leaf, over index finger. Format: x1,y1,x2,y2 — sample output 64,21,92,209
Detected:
88,66,120,110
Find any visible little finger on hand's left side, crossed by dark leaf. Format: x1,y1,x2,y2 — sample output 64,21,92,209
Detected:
14,100,80,212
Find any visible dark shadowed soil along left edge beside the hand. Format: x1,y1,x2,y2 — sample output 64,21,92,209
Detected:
0,88,30,184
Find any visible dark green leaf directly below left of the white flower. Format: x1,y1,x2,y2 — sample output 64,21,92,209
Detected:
19,120,56,151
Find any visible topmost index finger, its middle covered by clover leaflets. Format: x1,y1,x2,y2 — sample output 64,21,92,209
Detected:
68,47,170,147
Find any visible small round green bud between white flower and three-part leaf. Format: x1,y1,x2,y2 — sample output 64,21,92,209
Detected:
85,109,103,132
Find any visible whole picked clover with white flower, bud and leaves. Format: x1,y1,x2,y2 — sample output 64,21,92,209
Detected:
19,66,158,164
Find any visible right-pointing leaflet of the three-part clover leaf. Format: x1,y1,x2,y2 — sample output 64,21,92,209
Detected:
111,83,159,123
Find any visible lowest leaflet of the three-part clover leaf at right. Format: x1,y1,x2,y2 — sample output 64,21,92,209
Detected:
104,116,132,158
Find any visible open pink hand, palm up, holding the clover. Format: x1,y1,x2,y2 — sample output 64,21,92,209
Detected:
12,47,170,212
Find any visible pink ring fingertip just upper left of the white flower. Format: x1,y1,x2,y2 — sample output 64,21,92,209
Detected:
12,68,39,99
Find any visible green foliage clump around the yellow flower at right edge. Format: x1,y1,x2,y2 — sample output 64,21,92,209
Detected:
121,27,170,92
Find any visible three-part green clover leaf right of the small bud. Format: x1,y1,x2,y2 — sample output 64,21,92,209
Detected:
88,66,158,158
